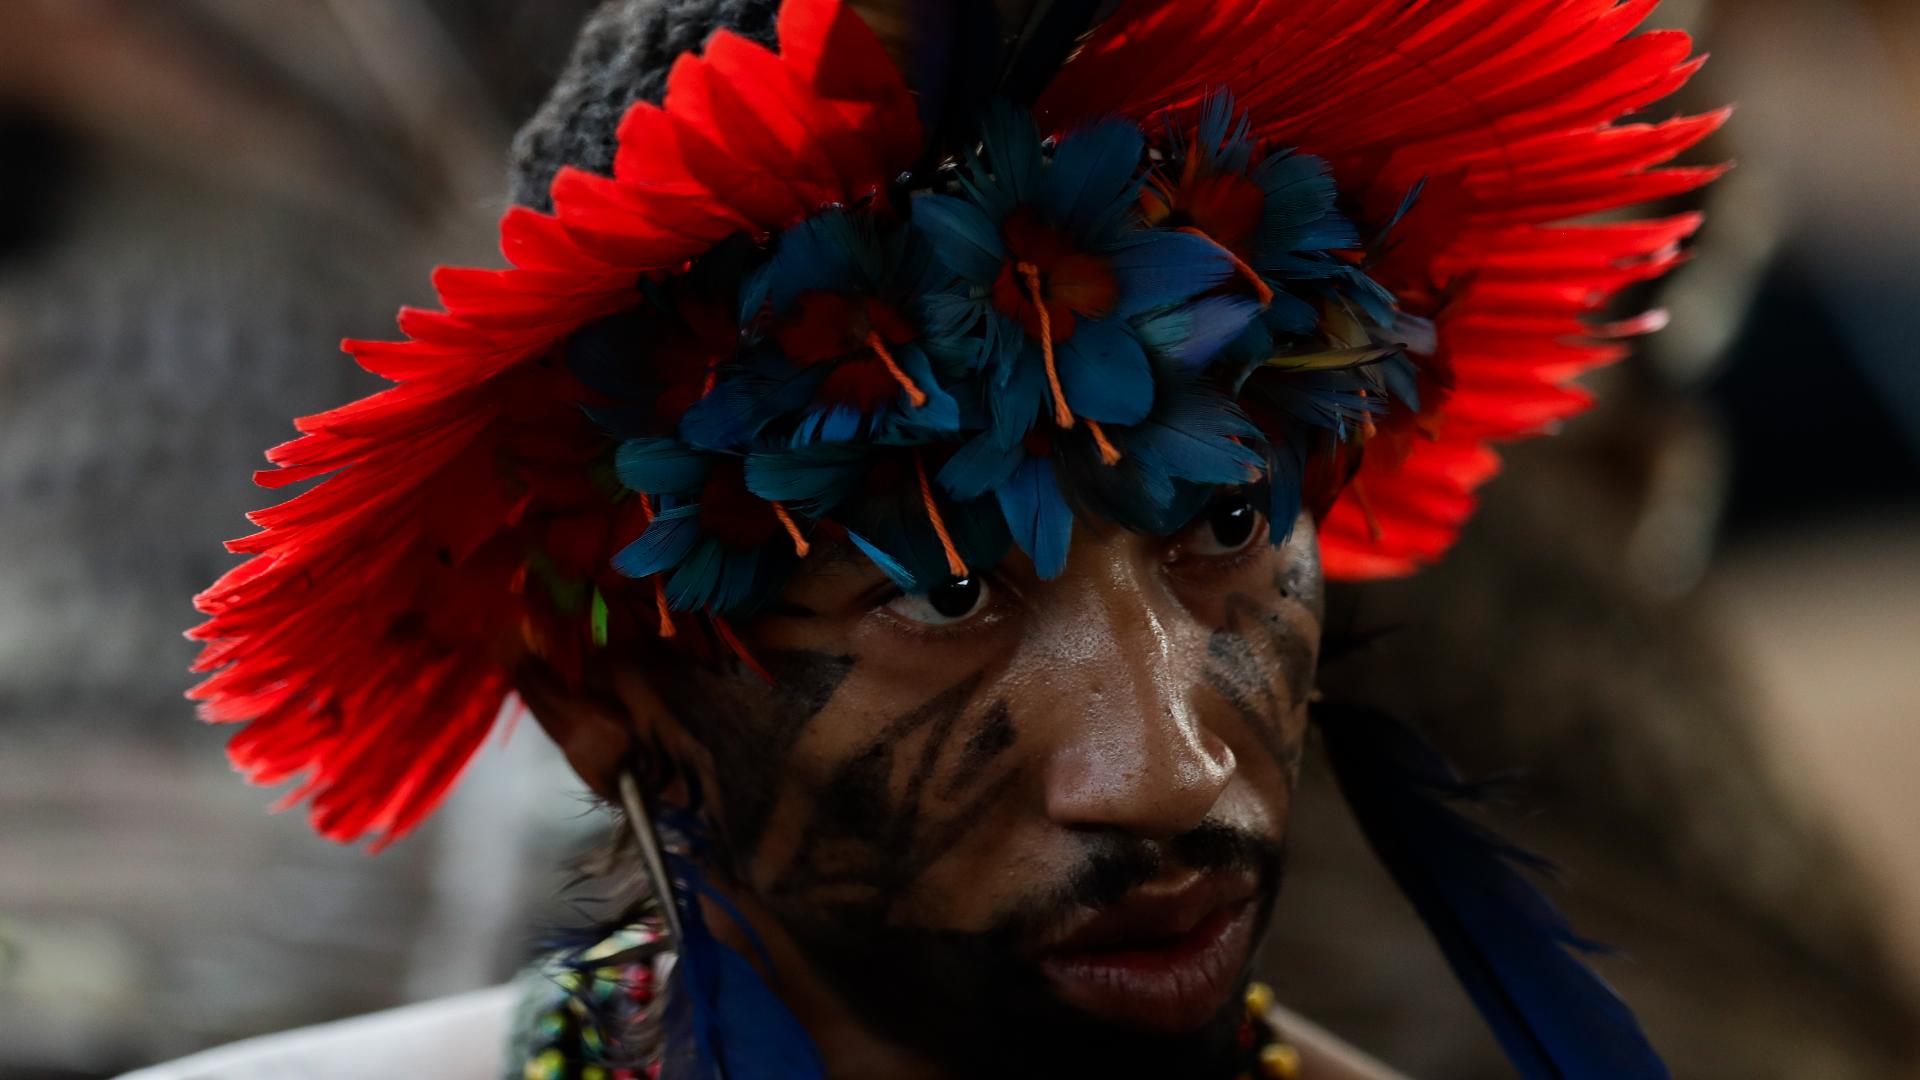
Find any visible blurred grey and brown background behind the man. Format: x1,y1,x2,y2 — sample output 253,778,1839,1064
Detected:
0,0,1920,1080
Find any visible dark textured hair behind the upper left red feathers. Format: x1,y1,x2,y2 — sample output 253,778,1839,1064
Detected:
513,0,780,209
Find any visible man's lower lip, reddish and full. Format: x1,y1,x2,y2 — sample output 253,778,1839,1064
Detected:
1041,901,1254,1034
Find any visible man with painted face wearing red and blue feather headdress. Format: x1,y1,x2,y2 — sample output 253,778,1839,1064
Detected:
168,0,1718,1080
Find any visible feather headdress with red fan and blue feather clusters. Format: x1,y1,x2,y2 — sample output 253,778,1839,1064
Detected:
192,0,1724,1068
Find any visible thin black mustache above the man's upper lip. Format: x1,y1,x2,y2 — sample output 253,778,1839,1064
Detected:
993,819,1286,942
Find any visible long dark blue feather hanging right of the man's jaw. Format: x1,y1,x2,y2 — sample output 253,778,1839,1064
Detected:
1315,705,1668,1080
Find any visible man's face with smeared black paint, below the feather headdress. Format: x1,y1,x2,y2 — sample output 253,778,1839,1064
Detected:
653,496,1321,1076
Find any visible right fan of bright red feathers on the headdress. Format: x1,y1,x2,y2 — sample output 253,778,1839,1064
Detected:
1039,0,1728,578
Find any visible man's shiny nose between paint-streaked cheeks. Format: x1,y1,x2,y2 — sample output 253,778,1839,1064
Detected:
1044,545,1235,840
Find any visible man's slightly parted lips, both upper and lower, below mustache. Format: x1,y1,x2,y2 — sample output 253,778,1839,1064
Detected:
1039,874,1256,1034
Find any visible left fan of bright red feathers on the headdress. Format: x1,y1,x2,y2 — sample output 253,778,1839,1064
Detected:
190,0,922,846
